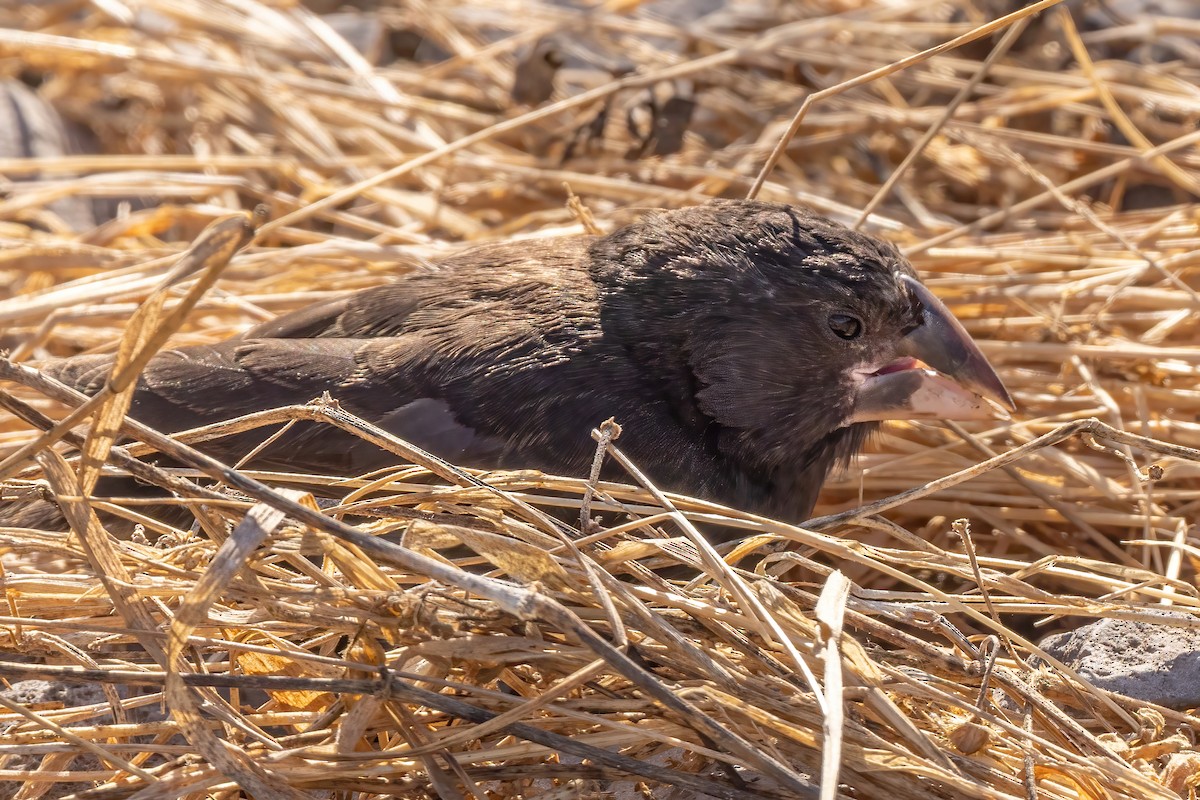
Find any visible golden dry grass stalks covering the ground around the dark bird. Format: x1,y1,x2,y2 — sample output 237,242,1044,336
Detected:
0,0,1200,800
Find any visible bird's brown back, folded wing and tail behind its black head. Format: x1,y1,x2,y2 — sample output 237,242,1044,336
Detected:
32,237,740,497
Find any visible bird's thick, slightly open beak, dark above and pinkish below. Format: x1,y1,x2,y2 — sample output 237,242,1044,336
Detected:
846,275,1016,425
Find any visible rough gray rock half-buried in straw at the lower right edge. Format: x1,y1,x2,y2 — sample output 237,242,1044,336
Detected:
1042,612,1200,710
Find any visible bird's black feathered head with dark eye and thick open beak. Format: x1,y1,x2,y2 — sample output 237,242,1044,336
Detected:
593,200,1013,489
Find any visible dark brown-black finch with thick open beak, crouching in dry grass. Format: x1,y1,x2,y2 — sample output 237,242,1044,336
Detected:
7,200,1014,534
